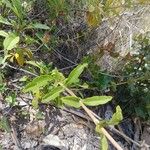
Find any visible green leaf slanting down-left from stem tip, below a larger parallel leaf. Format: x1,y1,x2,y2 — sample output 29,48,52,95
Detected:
42,86,64,103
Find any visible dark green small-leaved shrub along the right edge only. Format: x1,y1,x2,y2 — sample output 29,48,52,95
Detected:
116,35,150,120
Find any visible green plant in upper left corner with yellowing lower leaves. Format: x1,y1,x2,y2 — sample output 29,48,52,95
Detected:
0,0,50,66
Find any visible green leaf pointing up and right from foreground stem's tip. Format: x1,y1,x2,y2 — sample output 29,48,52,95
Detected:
66,63,88,85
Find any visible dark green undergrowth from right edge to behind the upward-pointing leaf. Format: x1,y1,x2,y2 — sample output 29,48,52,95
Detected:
83,34,150,120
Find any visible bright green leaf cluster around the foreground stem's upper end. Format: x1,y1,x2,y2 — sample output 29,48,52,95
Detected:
23,63,112,108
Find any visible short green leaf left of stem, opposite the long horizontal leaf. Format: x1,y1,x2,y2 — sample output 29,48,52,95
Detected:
61,96,80,108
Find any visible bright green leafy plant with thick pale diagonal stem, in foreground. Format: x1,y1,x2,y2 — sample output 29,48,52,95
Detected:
23,63,122,147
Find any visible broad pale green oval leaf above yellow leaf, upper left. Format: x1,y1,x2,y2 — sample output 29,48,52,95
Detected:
3,33,20,50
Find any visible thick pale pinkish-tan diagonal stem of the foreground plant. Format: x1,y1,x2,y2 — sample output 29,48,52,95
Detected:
59,83,123,150
